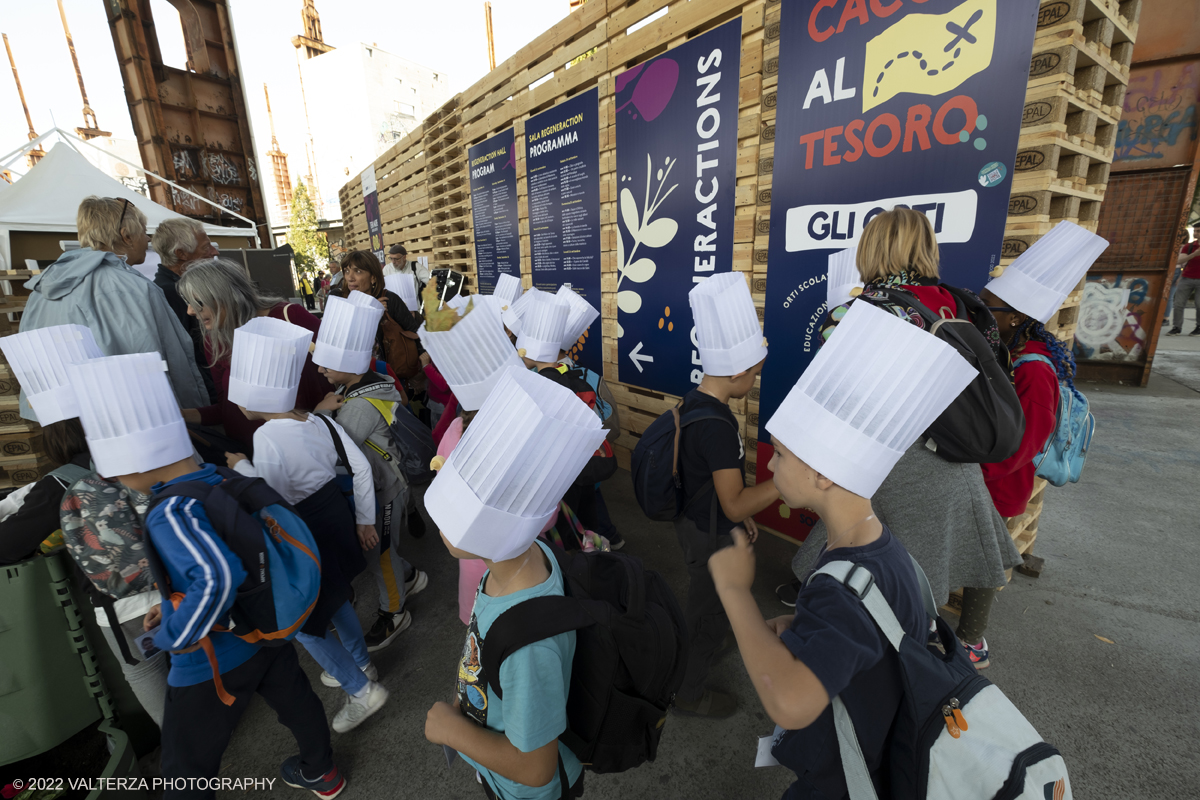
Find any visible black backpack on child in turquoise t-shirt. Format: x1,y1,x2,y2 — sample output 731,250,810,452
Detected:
480,547,688,772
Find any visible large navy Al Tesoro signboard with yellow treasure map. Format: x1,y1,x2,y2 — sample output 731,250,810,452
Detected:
756,0,1038,539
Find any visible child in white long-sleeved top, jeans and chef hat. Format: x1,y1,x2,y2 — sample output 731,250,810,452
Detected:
227,316,388,733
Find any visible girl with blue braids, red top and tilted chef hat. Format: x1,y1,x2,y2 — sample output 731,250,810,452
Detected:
974,222,1109,667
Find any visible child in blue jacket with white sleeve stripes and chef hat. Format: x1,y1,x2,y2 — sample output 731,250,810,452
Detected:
68,352,346,796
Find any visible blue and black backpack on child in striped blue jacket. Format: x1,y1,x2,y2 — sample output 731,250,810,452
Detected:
146,467,320,645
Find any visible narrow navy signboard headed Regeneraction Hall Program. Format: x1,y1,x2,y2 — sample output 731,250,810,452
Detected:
467,128,521,294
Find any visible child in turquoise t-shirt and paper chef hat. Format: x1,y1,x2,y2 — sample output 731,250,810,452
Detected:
425,367,605,798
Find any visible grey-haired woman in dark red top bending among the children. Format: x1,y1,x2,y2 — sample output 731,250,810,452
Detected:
175,258,332,453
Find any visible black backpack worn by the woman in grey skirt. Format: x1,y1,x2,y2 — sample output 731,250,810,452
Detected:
859,284,1025,464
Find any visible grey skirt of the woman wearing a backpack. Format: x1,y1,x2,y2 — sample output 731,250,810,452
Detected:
792,438,1021,606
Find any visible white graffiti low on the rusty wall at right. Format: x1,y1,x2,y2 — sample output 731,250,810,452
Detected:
1075,272,1163,362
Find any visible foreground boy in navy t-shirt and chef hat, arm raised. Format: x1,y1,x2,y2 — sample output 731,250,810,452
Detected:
708,303,977,796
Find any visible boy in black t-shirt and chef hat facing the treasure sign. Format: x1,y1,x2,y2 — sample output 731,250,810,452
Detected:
674,272,779,718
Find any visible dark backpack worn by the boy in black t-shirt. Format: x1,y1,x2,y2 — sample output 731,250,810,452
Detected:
629,402,730,522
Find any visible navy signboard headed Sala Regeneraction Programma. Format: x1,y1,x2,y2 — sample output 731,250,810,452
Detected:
526,89,604,372
